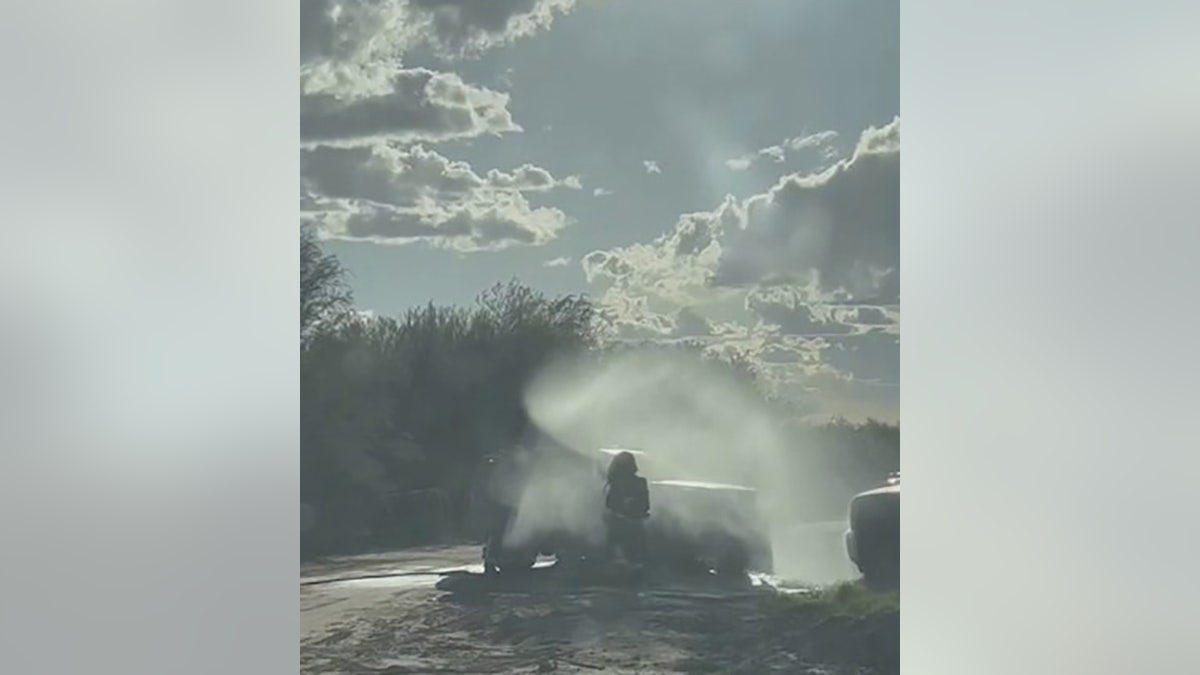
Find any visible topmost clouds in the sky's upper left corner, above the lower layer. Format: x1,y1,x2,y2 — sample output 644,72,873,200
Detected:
300,0,556,145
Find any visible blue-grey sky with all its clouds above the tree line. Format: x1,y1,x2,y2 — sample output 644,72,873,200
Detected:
300,0,900,422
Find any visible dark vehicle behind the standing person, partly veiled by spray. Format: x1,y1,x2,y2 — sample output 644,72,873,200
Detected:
485,447,774,575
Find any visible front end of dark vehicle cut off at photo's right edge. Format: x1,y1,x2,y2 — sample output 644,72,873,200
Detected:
845,472,900,589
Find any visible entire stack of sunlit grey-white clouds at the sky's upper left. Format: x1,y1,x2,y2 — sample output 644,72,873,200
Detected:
300,0,583,251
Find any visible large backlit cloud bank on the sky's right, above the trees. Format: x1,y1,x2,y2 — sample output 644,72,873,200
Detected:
582,119,899,417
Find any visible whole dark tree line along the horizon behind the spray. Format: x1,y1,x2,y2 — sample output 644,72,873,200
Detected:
300,229,900,556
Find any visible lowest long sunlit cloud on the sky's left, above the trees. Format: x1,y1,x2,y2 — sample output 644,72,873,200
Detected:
300,144,578,251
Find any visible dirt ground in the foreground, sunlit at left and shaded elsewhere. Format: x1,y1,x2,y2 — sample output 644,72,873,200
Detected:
300,548,900,675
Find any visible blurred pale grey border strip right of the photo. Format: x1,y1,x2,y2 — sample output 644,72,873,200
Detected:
901,0,1200,675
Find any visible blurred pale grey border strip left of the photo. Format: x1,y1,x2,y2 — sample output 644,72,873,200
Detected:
0,0,299,675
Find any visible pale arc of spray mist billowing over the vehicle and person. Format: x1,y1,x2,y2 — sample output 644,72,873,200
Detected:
508,350,853,581
